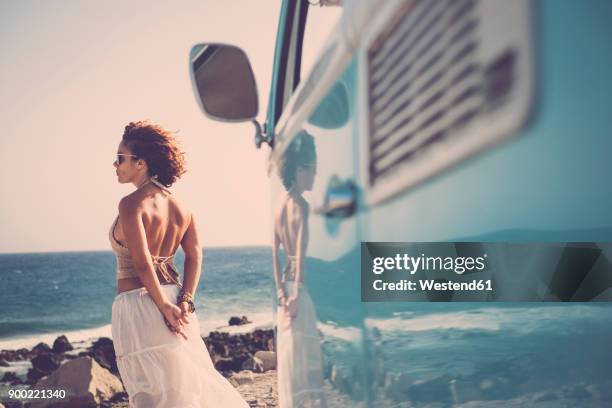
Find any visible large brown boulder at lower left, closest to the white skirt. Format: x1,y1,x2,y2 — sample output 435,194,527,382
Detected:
31,357,125,408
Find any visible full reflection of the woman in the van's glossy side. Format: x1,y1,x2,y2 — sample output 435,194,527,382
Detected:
273,132,326,408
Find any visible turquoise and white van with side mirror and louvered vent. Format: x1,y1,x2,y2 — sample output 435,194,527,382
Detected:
191,0,612,407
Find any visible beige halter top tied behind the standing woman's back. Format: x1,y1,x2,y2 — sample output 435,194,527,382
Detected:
108,216,180,286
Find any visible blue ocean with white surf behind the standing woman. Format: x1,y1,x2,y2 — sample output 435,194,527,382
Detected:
0,247,274,350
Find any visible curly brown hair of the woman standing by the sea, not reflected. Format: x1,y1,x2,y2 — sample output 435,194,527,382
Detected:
122,121,187,187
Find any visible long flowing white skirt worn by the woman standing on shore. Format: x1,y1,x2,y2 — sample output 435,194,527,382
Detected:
112,285,248,408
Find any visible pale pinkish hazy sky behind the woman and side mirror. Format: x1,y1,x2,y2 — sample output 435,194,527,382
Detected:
0,0,294,253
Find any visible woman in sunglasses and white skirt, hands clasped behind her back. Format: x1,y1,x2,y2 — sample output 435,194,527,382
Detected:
109,122,248,408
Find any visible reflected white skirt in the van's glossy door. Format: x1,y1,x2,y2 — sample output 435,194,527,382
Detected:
276,282,326,408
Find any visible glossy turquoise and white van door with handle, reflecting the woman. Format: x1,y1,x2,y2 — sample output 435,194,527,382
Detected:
267,1,366,406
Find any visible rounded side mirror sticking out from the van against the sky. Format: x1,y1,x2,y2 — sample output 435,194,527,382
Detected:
189,43,259,122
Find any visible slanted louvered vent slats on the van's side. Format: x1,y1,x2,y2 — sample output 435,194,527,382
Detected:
368,0,486,186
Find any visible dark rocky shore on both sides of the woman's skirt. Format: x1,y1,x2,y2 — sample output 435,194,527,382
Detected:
0,316,277,408
